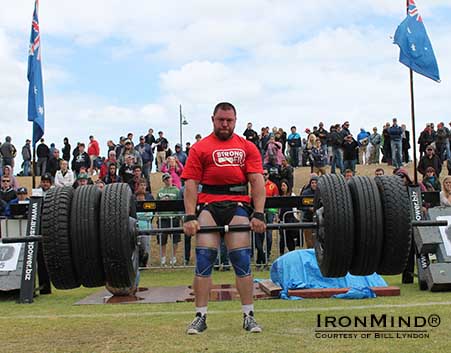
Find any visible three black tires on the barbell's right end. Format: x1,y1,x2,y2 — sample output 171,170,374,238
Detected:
315,174,411,277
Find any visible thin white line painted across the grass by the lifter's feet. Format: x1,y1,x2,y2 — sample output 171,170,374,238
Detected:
0,301,451,320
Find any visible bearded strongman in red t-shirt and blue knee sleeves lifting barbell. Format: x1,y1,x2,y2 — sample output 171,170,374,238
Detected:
182,103,266,334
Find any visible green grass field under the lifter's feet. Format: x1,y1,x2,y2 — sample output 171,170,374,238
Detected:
0,270,451,353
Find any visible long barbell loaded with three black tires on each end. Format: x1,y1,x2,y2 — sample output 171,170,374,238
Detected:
3,174,447,295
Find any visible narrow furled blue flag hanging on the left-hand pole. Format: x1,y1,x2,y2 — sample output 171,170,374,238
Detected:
27,0,44,146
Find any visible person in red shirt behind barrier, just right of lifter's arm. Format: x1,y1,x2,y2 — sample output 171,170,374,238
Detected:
255,169,279,266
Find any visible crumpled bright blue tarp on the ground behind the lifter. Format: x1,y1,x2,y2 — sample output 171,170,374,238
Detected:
270,249,387,300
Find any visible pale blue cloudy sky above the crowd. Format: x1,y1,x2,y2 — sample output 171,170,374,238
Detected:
0,0,451,153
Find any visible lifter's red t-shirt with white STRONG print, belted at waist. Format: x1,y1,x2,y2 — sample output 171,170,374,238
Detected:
182,133,263,203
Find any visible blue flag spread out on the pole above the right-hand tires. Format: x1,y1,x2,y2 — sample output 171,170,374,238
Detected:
394,0,440,82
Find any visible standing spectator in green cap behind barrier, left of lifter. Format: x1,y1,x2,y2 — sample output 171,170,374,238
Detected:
157,173,180,266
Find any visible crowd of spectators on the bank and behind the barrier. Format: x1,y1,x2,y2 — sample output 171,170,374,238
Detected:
0,118,451,264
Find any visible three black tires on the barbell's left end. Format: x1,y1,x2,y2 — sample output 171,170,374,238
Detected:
41,184,138,295
